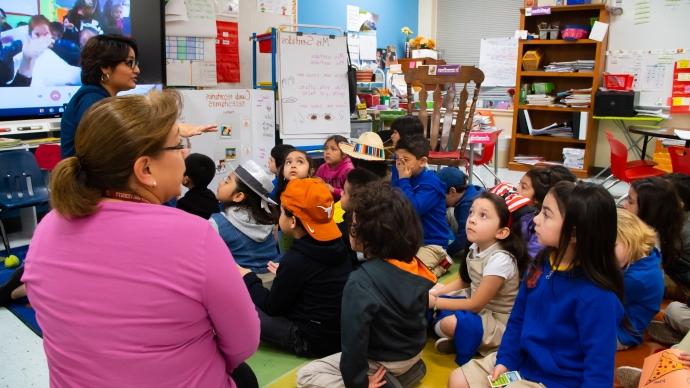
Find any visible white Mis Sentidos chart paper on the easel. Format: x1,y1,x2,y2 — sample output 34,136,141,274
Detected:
277,32,350,139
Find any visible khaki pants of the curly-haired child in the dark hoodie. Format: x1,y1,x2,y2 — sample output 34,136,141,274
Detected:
297,352,422,388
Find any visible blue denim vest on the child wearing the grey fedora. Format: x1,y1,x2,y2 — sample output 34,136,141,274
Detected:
211,213,279,273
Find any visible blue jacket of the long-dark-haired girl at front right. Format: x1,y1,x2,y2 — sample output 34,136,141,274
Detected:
496,263,623,388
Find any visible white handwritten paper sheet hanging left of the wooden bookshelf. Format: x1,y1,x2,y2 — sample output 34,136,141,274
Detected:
479,38,518,86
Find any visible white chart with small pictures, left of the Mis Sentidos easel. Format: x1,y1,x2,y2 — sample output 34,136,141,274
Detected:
180,89,275,190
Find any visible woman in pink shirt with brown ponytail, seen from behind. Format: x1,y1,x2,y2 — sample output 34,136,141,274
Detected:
22,91,259,388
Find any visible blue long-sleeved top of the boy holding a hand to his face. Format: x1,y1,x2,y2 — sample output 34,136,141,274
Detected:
392,169,449,249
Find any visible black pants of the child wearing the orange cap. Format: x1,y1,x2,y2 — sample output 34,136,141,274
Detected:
256,308,309,356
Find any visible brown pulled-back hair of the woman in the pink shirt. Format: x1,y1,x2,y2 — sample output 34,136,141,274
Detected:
50,90,181,218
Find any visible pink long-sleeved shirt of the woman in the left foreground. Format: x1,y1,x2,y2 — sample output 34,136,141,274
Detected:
22,202,259,388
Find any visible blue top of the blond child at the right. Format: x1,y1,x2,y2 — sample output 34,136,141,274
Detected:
618,248,664,346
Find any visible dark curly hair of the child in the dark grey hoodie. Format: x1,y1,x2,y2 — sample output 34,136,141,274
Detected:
350,182,423,262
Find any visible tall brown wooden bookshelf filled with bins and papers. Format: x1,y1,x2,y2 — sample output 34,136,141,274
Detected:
508,4,609,178
